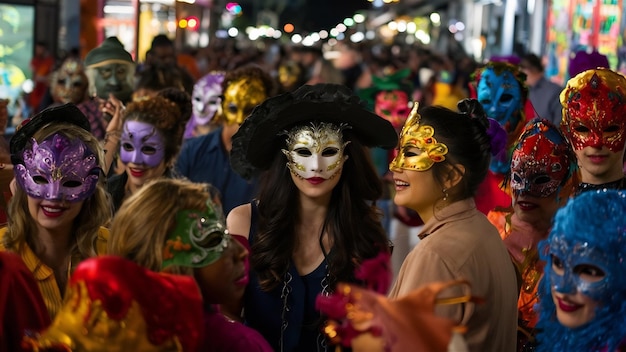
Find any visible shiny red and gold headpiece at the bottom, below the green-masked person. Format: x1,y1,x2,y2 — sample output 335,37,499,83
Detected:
25,256,203,351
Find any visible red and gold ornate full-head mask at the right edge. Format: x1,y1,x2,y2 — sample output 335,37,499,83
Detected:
561,68,626,153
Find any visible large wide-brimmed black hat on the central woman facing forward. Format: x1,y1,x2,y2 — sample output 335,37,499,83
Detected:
230,83,398,178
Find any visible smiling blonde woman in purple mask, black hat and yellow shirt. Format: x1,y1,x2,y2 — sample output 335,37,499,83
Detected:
0,104,111,318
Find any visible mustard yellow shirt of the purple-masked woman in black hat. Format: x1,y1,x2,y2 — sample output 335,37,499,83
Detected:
0,227,109,319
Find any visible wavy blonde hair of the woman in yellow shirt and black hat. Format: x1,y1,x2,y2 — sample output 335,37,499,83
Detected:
2,123,112,259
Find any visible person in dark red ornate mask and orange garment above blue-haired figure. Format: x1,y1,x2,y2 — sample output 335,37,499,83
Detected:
488,119,580,352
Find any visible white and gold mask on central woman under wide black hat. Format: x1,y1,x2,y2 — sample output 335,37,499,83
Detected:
282,122,349,180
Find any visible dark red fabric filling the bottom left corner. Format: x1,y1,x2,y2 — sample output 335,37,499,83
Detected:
0,252,50,352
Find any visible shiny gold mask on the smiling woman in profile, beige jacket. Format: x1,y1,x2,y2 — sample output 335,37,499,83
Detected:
389,103,448,171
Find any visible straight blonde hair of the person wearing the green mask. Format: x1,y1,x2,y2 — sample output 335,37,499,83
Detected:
108,178,215,274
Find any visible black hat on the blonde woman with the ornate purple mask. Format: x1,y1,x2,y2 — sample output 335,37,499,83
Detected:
9,103,91,165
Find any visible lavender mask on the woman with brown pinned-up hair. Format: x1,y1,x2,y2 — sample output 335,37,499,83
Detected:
120,121,165,167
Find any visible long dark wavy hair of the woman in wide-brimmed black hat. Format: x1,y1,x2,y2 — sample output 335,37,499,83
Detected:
250,130,389,291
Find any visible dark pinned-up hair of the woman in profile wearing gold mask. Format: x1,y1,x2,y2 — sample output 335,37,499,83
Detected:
419,99,492,201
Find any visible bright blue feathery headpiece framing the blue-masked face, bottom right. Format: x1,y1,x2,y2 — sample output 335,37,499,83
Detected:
537,190,626,351
